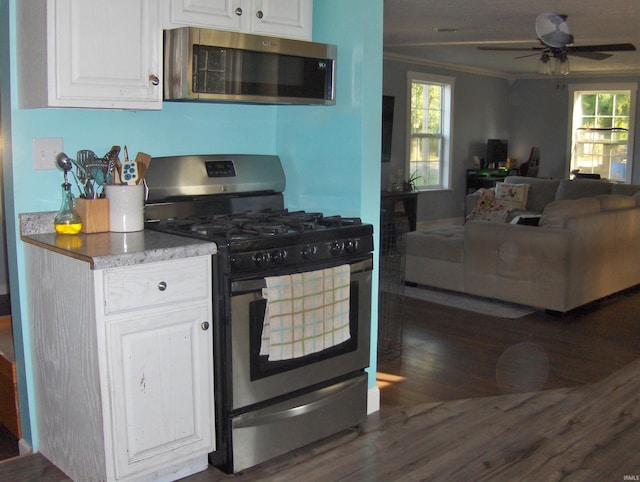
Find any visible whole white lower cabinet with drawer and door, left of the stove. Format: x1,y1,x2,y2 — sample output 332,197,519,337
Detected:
25,249,215,481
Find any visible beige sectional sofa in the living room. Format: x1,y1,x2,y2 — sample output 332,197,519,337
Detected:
405,177,640,312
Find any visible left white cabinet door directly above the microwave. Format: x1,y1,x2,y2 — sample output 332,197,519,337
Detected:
165,0,243,31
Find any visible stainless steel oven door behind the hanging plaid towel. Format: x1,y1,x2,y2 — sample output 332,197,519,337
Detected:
230,256,373,410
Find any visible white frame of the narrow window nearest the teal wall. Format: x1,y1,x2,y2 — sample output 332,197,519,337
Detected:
405,71,455,191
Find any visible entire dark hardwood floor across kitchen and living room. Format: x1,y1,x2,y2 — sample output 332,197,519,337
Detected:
0,288,640,482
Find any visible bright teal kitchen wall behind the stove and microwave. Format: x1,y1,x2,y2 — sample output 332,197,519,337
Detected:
0,0,383,449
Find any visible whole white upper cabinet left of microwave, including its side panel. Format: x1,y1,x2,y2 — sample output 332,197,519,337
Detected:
17,0,162,109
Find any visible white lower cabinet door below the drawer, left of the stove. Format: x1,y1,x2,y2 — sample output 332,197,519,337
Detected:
105,303,214,479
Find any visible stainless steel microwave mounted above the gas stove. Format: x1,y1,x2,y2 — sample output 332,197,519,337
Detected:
164,27,337,105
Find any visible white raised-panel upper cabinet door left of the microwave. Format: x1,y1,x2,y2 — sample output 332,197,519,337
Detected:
47,0,162,109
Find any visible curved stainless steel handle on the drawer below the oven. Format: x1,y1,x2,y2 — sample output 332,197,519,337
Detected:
233,377,363,429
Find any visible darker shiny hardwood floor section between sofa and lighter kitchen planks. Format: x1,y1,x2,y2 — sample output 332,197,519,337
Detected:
378,287,640,407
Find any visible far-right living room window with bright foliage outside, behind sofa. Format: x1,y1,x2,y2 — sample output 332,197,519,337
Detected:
570,84,637,182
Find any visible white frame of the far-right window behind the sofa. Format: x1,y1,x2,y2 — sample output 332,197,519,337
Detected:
565,82,638,183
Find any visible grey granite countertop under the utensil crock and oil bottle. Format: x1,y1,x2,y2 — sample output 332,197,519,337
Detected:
20,212,217,269
